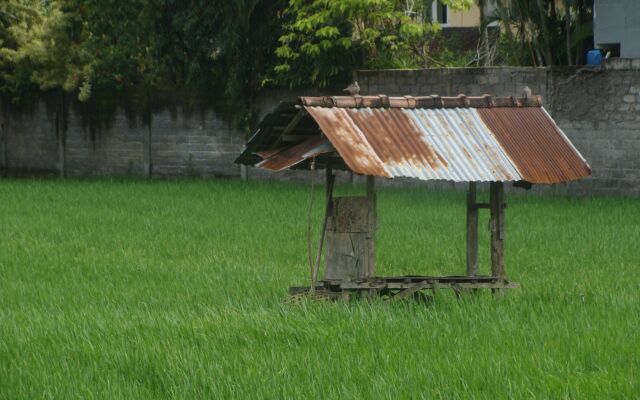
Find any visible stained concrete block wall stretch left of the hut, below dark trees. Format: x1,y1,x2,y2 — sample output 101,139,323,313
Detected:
0,96,244,177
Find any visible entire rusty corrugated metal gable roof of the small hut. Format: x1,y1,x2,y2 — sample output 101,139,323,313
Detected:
237,96,591,183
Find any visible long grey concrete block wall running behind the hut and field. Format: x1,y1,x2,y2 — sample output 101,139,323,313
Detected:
0,59,640,196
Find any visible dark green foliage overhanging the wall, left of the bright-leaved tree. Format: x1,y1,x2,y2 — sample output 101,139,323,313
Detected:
0,0,282,125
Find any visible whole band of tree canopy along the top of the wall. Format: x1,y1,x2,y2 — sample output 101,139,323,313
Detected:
0,0,593,123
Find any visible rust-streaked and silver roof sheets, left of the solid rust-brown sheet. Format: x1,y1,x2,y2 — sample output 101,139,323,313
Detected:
307,107,522,182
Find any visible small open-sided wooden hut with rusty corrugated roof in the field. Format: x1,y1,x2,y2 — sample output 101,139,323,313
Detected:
236,95,591,297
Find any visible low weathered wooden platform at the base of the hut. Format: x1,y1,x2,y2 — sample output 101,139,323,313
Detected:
289,275,520,299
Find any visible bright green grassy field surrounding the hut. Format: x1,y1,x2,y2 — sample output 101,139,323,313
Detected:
0,180,640,399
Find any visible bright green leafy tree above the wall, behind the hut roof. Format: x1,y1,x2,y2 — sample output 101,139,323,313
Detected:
275,0,471,86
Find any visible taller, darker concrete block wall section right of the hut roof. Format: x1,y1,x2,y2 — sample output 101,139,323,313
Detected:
549,60,640,196
